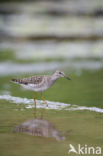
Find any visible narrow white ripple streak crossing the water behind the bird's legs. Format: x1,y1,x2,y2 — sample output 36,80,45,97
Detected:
0,95,103,113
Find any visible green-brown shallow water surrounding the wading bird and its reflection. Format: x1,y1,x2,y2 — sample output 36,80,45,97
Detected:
0,58,103,156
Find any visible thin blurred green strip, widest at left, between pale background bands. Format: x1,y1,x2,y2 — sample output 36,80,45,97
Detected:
0,49,103,64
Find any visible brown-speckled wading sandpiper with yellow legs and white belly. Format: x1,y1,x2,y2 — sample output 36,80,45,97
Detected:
12,70,70,118
